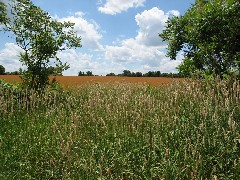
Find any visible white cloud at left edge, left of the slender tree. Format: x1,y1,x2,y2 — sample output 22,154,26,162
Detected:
0,43,23,72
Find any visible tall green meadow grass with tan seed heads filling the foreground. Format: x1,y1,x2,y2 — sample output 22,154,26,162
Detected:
0,81,240,179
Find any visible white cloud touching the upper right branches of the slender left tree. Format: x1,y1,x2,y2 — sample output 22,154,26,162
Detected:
56,12,103,50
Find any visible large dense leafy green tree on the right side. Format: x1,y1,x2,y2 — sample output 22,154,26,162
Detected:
160,0,240,76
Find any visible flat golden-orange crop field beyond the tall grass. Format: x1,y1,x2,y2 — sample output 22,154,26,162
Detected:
0,75,183,86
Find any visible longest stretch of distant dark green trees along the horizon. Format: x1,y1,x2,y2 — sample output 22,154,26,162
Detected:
106,70,183,78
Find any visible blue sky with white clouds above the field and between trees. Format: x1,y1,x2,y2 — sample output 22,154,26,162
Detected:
0,0,195,76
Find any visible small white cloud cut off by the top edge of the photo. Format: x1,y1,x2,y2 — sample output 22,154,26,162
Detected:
98,0,146,15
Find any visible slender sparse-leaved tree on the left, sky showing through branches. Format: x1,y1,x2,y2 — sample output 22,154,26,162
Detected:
1,0,81,89
